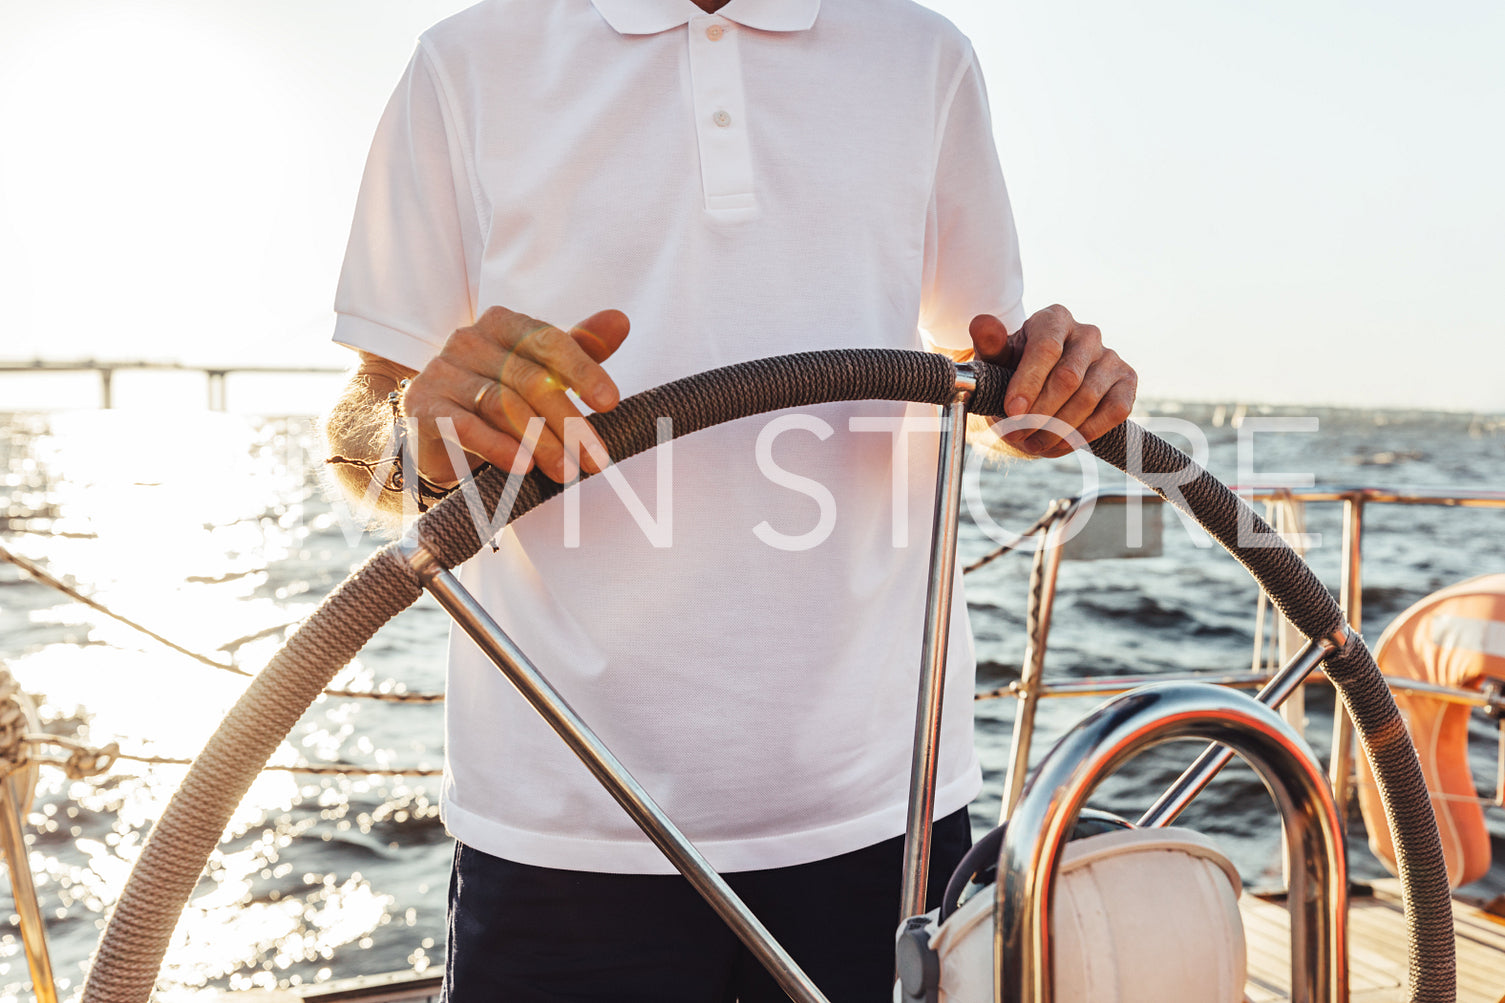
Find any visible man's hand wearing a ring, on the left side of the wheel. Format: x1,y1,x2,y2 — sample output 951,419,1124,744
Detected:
403,307,629,485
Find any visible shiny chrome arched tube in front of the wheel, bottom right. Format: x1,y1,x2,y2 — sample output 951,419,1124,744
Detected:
993,682,1348,1003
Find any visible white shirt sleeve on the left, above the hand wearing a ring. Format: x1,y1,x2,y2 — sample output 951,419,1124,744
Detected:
334,45,480,369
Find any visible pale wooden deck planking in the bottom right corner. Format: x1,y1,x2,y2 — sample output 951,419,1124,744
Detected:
1239,880,1505,1003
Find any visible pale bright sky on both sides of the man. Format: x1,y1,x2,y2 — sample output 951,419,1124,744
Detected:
0,0,1505,413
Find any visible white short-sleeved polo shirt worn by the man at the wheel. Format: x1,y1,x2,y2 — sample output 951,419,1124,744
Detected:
334,0,1023,872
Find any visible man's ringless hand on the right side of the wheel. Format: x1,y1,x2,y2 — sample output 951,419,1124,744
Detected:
971,306,1139,456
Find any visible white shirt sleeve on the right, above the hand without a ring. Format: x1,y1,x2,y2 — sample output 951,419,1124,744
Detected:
920,53,1025,348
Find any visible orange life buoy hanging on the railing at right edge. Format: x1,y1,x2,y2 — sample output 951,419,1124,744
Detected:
1358,574,1505,887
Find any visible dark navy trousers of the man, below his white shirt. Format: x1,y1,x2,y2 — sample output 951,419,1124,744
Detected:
442,809,972,1003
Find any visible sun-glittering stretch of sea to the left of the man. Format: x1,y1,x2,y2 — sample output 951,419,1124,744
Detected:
0,410,442,1003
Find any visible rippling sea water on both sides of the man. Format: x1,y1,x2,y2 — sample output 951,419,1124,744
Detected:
0,405,1505,1001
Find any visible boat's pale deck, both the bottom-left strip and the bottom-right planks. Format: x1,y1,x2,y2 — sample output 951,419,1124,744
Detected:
221,880,1505,1003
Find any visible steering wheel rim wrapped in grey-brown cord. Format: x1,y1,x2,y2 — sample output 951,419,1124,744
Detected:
83,349,1455,1003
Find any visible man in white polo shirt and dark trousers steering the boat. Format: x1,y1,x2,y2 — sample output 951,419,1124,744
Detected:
330,0,1135,1003
